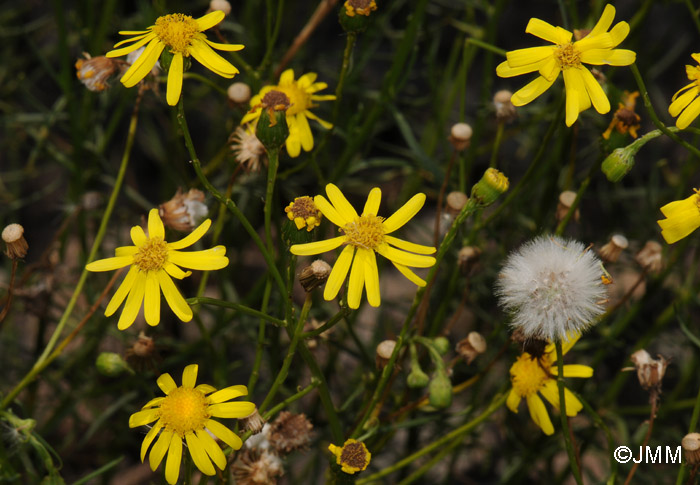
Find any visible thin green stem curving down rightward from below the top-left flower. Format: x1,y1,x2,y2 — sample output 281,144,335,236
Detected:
177,97,287,295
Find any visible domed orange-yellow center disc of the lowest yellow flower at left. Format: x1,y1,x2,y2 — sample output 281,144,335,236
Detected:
160,387,210,437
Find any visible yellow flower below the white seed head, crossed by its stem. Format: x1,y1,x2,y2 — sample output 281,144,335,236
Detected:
506,334,593,435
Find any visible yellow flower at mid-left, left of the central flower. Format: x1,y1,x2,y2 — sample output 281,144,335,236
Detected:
85,209,228,330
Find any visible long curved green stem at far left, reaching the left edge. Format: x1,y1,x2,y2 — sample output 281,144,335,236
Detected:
0,88,143,409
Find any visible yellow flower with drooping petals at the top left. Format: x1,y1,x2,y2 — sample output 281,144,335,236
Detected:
106,10,244,106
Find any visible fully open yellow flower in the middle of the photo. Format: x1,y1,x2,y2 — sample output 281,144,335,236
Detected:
290,184,435,308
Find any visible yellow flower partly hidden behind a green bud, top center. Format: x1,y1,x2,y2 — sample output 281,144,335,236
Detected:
241,69,335,158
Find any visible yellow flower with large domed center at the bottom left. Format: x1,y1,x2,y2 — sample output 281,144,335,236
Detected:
129,364,255,485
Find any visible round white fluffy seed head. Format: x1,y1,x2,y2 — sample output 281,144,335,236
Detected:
496,236,606,341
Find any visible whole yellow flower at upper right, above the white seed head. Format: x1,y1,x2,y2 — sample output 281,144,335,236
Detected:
496,5,636,126
